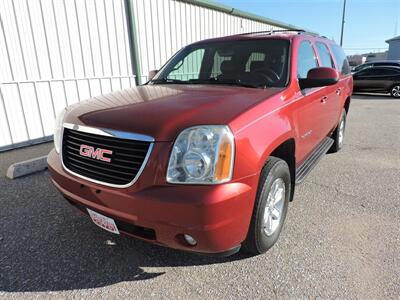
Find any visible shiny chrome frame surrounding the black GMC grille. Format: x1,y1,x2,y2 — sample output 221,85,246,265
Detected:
60,123,155,189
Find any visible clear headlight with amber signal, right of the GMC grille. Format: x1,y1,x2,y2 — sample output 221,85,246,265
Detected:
167,125,235,184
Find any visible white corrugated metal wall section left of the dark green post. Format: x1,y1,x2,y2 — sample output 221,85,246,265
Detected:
0,0,134,150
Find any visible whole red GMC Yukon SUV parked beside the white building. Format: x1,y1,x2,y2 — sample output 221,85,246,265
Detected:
48,31,353,255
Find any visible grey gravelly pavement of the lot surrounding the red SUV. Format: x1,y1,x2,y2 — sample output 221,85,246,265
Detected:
0,96,400,299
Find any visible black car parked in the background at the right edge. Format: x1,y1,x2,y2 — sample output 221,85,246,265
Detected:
353,67,400,98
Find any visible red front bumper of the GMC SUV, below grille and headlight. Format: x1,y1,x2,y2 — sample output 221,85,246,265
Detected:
48,150,258,254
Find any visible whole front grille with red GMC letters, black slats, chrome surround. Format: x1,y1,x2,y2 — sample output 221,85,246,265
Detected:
62,124,153,187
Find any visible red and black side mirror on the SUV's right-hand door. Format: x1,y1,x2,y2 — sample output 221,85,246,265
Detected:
299,67,339,90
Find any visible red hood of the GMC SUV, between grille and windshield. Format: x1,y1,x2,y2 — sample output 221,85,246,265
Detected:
65,85,282,141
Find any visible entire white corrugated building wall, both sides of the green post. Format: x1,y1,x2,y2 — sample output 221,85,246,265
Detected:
0,0,288,151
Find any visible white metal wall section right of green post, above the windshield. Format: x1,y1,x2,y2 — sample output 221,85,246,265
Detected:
133,0,280,82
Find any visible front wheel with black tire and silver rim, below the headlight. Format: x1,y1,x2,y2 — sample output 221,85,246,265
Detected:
242,157,291,255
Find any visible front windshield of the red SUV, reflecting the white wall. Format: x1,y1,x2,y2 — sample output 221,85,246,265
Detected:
150,39,289,88
